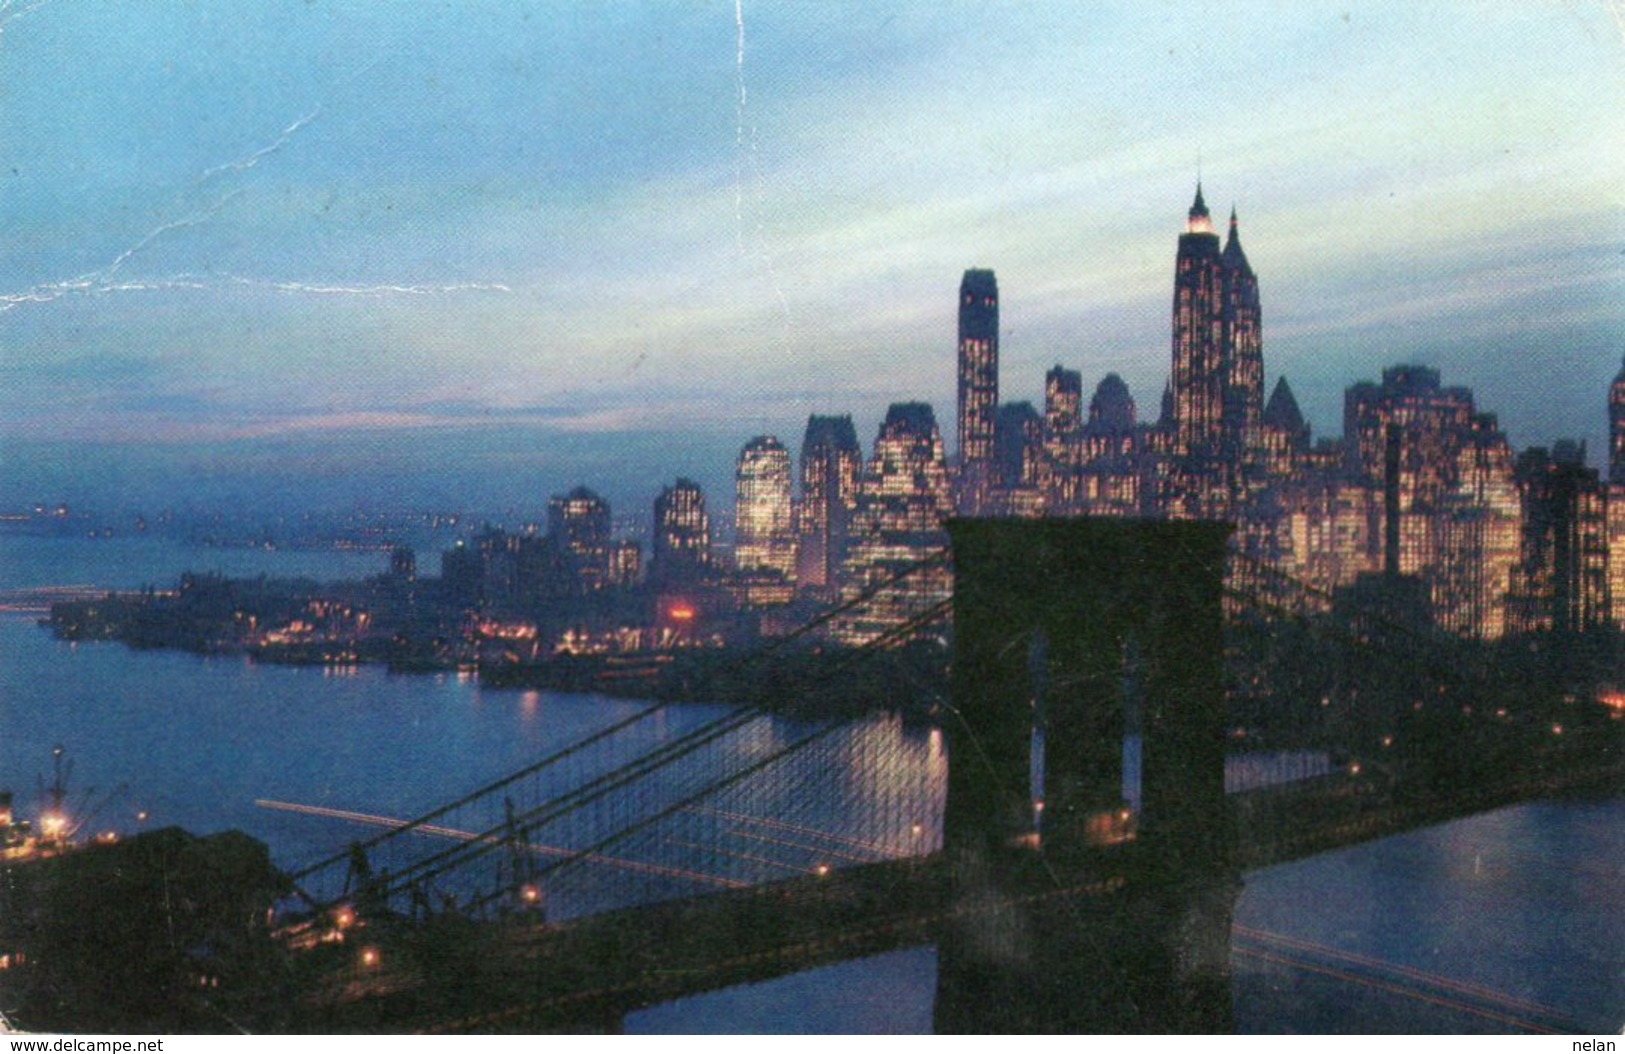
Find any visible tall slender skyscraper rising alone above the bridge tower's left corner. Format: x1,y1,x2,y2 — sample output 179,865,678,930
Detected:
959,270,999,512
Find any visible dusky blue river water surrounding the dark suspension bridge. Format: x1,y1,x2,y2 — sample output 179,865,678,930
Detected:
0,536,1625,1033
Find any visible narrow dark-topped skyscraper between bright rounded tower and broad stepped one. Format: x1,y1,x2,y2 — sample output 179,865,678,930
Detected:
796,414,863,590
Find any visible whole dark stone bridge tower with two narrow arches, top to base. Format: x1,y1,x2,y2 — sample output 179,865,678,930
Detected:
936,520,1240,1031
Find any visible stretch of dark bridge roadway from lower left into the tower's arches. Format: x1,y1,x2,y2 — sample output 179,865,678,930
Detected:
302,853,1126,1031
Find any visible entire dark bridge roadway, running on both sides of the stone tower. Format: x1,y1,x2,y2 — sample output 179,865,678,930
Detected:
299,760,1625,1031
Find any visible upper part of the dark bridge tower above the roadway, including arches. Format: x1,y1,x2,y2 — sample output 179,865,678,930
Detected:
944,520,1230,869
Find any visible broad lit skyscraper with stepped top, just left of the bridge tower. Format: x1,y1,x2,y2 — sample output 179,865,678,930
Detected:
835,403,952,645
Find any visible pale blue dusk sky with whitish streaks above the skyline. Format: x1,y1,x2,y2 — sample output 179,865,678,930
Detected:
0,0,1625,502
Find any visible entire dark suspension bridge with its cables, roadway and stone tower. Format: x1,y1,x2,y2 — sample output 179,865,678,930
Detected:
6,520,1620,1033
